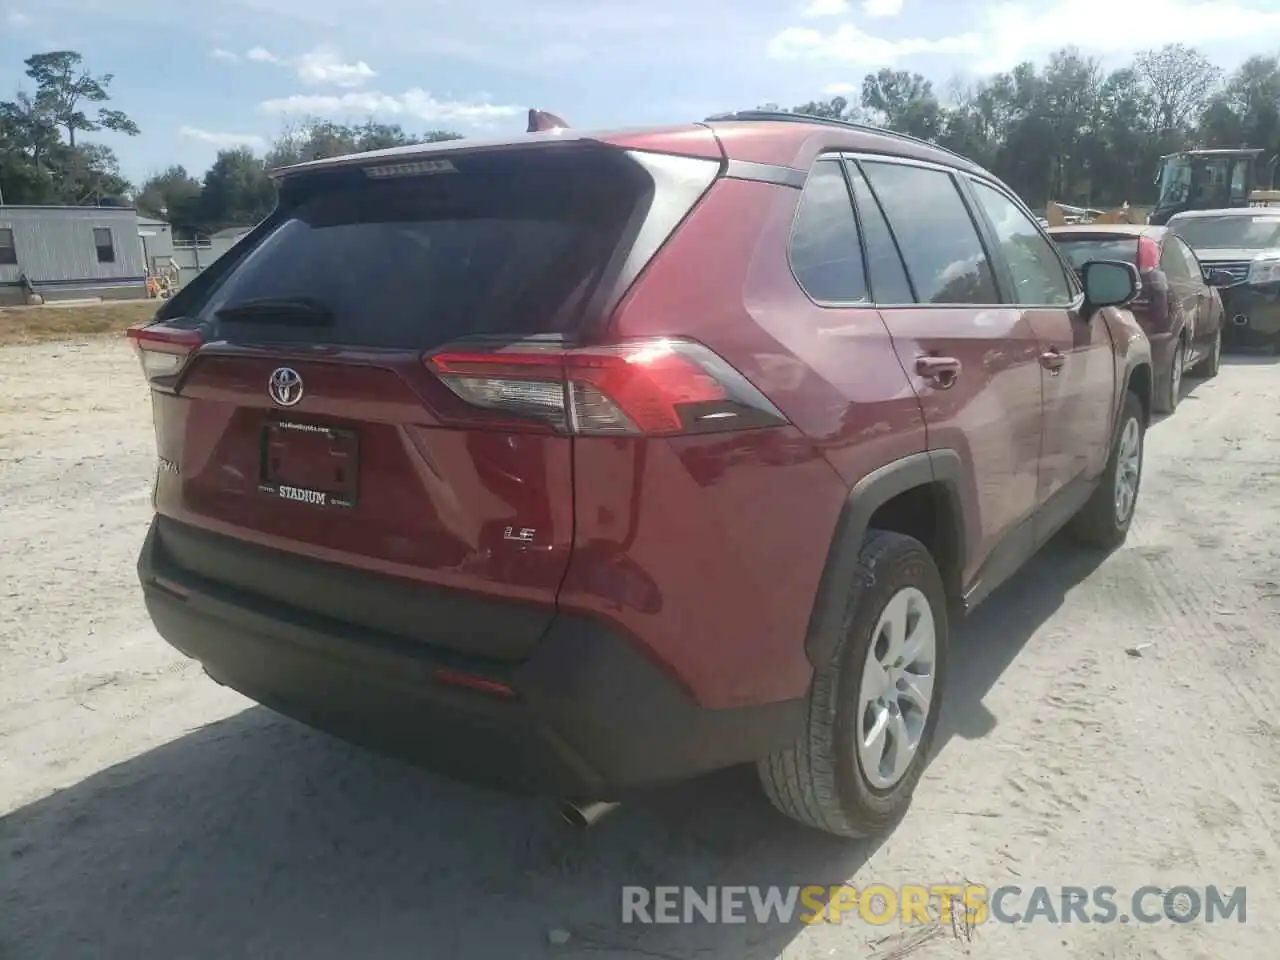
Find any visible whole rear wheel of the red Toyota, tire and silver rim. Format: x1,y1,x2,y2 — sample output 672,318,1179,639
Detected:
759,530,947,837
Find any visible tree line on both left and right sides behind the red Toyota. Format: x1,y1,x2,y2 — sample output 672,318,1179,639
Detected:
0,44,1280,233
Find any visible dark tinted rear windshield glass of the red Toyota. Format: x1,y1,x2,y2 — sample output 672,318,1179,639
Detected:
198,150,644,349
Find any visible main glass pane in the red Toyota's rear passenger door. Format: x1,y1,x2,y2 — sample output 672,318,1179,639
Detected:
861,161,1000,303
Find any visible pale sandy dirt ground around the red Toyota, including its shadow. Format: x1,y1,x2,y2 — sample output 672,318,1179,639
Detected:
0,339,1280,960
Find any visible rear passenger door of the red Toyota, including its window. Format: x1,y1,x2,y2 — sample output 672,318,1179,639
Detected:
850,156,1042,594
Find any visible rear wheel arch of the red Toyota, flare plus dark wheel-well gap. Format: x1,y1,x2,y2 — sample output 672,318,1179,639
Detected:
805,449,975,667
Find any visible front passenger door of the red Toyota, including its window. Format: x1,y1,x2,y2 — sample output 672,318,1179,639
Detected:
969,178,1115,544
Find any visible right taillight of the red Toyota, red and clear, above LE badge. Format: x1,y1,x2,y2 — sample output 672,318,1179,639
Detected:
424,339,787,436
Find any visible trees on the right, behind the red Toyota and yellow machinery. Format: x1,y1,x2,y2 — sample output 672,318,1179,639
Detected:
778,44,1280,207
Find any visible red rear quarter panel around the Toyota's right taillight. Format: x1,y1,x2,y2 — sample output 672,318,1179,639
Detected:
559,180,923,707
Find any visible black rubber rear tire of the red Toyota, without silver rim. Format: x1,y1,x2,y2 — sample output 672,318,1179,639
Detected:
758,530,947,837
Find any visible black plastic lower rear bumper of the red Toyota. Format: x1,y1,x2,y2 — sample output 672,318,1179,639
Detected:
138,520,806,799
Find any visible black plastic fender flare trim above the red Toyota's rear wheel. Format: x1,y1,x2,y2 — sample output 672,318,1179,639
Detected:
805,449,977,668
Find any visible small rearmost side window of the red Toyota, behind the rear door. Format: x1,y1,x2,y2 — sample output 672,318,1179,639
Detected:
791,160,867,303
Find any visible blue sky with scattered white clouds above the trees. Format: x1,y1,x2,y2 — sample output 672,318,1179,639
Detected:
0,0,1280,180
